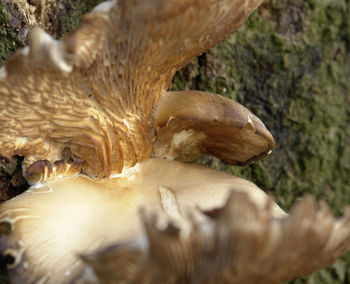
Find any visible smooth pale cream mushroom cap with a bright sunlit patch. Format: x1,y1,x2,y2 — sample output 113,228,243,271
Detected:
0,159,285,284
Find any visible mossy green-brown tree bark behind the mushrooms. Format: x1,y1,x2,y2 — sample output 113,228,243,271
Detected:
0,0,350,283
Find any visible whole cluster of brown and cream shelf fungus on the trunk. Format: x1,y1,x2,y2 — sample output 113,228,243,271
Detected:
0,0,350,284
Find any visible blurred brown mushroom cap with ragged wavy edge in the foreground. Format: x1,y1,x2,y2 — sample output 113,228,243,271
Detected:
74,192,350,284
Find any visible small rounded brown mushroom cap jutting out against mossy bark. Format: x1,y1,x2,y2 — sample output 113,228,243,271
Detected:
153,91,274,166
